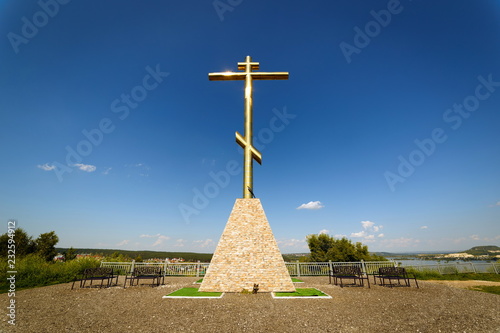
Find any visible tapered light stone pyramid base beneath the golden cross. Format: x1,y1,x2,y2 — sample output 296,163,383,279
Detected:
200,199,295,292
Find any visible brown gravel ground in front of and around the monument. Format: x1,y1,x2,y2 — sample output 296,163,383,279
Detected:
0,277,500,333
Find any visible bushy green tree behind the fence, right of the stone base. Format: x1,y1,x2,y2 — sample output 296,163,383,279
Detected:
307,234,386,262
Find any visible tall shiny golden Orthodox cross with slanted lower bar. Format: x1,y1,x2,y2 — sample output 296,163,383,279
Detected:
208,56,288,199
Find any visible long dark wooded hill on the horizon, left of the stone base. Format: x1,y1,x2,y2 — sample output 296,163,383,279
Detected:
56,248,212,262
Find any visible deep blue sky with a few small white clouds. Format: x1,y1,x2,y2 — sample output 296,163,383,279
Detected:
0,0,500,253
